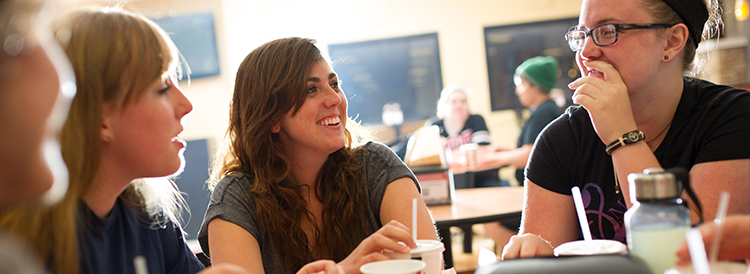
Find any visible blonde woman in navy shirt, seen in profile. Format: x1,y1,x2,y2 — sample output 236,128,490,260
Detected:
0,8,284,273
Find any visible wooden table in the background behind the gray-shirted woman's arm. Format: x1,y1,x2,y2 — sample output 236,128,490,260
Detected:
429,187,523,268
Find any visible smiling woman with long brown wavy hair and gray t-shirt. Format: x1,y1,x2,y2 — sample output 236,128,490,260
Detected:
198,38,437,273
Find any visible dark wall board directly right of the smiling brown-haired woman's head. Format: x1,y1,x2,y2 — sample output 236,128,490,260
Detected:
328,33,443,124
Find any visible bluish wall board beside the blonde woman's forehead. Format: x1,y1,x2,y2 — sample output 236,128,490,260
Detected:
153,12,219,80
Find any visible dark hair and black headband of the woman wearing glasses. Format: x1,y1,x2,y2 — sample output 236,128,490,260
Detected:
643,0,722,75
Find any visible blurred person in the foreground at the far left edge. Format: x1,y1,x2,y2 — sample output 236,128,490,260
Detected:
0,0,75,274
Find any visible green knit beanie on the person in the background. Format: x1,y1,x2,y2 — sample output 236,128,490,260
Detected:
516,56,559,93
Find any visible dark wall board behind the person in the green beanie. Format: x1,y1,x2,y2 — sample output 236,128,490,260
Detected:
484,18,579,110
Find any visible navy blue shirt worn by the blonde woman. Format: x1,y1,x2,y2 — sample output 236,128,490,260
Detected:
79,199,204,274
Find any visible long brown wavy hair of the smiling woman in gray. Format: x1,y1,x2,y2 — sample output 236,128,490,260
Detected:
209,37,369,273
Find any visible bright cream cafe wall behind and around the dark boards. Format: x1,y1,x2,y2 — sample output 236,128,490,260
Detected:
131,0,581,155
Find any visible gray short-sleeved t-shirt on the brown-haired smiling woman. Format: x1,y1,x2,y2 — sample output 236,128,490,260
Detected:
198,142,420,273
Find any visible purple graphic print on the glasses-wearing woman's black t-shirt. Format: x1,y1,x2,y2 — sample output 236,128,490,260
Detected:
581,183,627,243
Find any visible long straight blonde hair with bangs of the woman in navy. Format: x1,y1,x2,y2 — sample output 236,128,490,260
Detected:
0,7,185,273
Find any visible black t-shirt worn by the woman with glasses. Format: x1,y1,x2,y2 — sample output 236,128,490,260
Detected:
526,77,750,242
